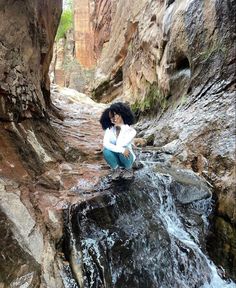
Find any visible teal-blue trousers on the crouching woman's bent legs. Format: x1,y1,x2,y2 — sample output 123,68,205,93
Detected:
103,148,134,169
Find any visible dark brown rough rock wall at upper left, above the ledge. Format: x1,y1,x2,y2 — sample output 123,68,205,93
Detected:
0,0,61,121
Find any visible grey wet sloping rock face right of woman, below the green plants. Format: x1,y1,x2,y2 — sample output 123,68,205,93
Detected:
137,91,236,277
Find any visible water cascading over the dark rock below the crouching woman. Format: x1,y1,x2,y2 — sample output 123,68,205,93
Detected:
63,155,236,288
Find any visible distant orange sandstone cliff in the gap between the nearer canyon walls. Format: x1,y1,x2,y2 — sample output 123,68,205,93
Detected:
50,0,112,93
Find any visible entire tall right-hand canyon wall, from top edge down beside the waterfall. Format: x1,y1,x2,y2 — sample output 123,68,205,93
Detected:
93,0,236,279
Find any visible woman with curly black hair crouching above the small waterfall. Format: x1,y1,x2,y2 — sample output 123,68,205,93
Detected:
100,102,136,180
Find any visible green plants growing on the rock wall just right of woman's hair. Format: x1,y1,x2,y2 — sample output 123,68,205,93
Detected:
132,82,167,115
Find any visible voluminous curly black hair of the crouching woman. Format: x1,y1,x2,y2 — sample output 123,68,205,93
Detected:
100,102,135,130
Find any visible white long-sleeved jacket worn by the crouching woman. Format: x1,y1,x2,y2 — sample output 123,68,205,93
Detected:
103,124,137,160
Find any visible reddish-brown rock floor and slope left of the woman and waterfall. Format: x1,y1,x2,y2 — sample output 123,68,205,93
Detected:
0,85,108,287
